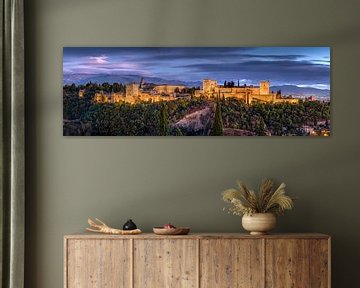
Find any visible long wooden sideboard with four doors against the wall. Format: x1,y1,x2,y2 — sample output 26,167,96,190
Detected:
64,233,331,288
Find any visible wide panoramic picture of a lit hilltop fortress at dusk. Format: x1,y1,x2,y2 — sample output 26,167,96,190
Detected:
63,47,331,137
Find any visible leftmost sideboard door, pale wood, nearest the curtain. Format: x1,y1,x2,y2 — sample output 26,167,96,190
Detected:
65,239,132,288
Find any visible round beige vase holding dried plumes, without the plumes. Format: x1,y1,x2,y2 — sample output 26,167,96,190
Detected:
242,213,276,235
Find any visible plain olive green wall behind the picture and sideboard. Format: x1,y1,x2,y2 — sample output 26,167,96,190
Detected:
25,0,360,288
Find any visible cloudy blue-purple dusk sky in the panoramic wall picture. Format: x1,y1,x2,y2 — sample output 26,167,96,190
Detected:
63,47,330,89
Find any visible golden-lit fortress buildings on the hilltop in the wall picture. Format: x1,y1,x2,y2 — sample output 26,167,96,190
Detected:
79,79,299,104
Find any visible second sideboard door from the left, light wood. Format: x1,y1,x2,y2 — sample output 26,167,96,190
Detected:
134,239,198,288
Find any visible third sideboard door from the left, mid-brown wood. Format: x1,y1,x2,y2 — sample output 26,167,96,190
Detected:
200,239,264,288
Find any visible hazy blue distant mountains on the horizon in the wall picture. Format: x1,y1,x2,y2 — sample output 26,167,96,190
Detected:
63,74,330,99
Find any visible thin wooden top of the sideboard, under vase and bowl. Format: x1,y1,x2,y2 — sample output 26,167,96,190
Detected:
64,232,330,239
